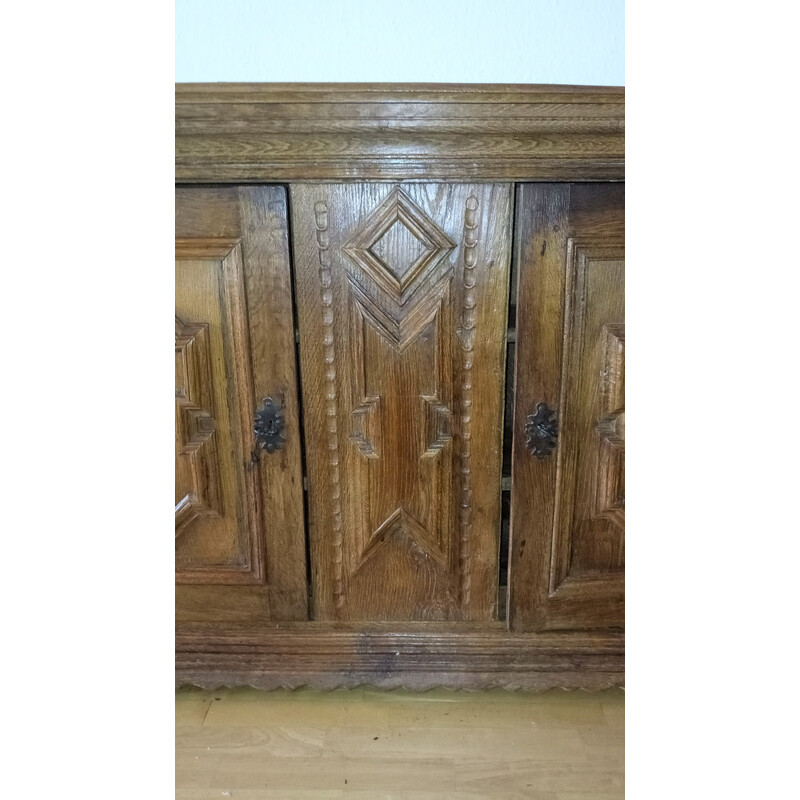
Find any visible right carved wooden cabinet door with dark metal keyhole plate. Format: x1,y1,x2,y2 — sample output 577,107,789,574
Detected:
509,184,625,630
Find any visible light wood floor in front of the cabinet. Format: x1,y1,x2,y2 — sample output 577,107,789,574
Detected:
175,689,624,800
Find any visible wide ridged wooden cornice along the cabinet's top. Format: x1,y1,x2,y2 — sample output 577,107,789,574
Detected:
175,83,625,183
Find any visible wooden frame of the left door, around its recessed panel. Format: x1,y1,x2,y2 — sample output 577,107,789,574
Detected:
175,186,308,627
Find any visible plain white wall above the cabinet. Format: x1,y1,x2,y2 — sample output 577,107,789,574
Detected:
175,0,625,86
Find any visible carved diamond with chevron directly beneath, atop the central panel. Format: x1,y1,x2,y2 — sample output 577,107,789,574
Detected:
342,188,456,350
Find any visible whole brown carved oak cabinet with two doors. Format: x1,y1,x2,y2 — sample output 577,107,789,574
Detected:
175,84,625,688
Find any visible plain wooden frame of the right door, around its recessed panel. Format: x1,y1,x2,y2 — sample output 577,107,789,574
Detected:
508,183,625,631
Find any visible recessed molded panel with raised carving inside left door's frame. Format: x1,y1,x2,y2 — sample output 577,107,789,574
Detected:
175,237,265,584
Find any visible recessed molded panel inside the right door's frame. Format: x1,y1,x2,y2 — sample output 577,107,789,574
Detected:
550,237,625,594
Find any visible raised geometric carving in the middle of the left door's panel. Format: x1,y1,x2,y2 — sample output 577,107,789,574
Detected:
175,317,220,538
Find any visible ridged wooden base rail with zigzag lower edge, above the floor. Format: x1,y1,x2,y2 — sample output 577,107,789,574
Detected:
176,622,624,691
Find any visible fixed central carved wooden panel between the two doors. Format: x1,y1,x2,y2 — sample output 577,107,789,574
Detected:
291,184,511,620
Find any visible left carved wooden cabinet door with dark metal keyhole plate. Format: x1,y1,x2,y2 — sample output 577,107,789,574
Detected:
175,187,307,624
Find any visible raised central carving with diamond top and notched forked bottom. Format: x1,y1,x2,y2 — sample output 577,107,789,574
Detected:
341,189,456,588
